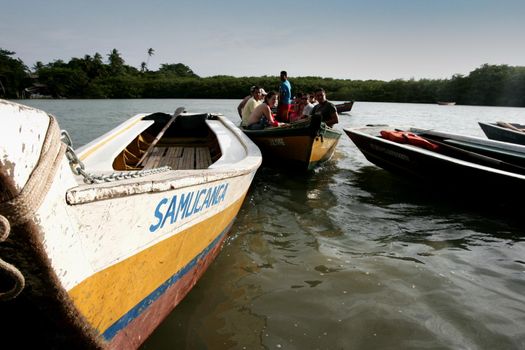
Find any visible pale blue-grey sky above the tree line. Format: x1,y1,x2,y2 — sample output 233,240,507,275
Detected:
0,0,525,81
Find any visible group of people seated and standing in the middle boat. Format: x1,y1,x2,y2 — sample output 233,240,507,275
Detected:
237,71,339,130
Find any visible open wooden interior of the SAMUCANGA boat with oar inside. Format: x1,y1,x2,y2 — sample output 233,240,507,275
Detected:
113,113,222,171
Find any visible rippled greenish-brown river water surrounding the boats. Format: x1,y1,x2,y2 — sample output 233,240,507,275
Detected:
13,100,525,350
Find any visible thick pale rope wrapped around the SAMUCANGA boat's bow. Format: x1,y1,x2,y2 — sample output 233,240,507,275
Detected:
0,115,66,300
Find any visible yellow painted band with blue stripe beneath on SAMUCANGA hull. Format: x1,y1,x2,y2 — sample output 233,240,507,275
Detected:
69,196,244,340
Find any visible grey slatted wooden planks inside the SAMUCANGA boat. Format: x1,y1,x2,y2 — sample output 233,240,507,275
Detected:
144,146,212,170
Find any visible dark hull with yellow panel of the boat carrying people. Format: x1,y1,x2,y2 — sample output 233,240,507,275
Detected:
242,115,342,171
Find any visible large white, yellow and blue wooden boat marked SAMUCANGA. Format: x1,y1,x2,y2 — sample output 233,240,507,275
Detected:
0,100,261,349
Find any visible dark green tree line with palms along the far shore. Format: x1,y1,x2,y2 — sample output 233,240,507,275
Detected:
0,48,525,107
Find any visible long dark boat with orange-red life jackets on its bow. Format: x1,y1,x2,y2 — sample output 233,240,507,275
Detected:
344,125,525,201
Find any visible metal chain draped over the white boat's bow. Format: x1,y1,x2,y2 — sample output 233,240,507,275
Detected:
61,130,171,184
